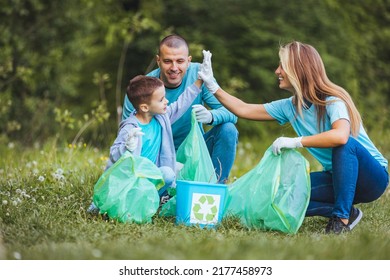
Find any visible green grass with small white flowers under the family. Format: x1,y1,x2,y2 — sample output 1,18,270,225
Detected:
0,138,390,260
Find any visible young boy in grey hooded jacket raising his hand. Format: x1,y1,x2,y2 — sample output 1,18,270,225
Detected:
87,75,203,213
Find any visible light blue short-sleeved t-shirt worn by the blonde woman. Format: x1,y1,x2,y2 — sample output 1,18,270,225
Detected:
264,97,388,171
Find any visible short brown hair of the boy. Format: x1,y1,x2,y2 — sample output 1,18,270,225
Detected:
126,75,164,109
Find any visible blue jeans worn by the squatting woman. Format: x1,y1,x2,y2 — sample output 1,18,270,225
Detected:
306,137,389,219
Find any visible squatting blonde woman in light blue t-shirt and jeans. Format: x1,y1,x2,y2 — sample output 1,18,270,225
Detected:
202,41,389,234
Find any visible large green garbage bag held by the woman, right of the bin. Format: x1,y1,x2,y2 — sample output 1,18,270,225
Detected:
225,147,310,234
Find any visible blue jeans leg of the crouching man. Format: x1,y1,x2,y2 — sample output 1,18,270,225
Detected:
203,122,238,184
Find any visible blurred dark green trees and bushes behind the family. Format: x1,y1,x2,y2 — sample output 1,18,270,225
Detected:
0,0,390,157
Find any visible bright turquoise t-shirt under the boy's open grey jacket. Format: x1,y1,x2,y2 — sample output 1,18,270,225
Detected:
138,118,162,163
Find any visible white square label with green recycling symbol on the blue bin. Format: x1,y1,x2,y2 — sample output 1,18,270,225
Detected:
191,194,220,223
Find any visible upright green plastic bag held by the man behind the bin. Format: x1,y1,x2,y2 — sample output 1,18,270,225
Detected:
176,111,217,183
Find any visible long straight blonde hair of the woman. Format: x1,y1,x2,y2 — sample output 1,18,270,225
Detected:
279,41,362,136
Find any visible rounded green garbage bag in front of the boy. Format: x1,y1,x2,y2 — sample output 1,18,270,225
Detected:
93,152,164,223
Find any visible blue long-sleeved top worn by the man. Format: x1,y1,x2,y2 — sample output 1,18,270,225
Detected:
122,62,237,150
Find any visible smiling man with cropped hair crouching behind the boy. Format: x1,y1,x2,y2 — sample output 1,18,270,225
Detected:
122,35,238,183
